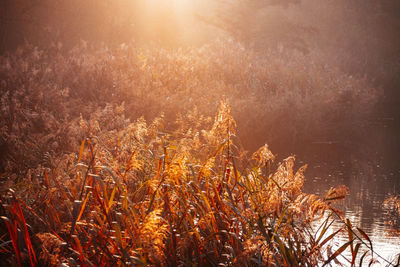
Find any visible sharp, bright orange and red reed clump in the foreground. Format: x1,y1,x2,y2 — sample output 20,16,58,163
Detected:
1,103,382,266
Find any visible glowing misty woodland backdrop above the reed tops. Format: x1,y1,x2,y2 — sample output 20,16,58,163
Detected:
0,0,400,157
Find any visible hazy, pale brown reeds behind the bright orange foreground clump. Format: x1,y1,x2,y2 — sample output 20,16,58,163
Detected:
0,41,380,178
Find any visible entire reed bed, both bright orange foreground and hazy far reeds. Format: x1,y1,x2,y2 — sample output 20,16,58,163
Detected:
0,41,388,266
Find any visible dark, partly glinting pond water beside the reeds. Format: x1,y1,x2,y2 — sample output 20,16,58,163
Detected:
297,117,400,266
